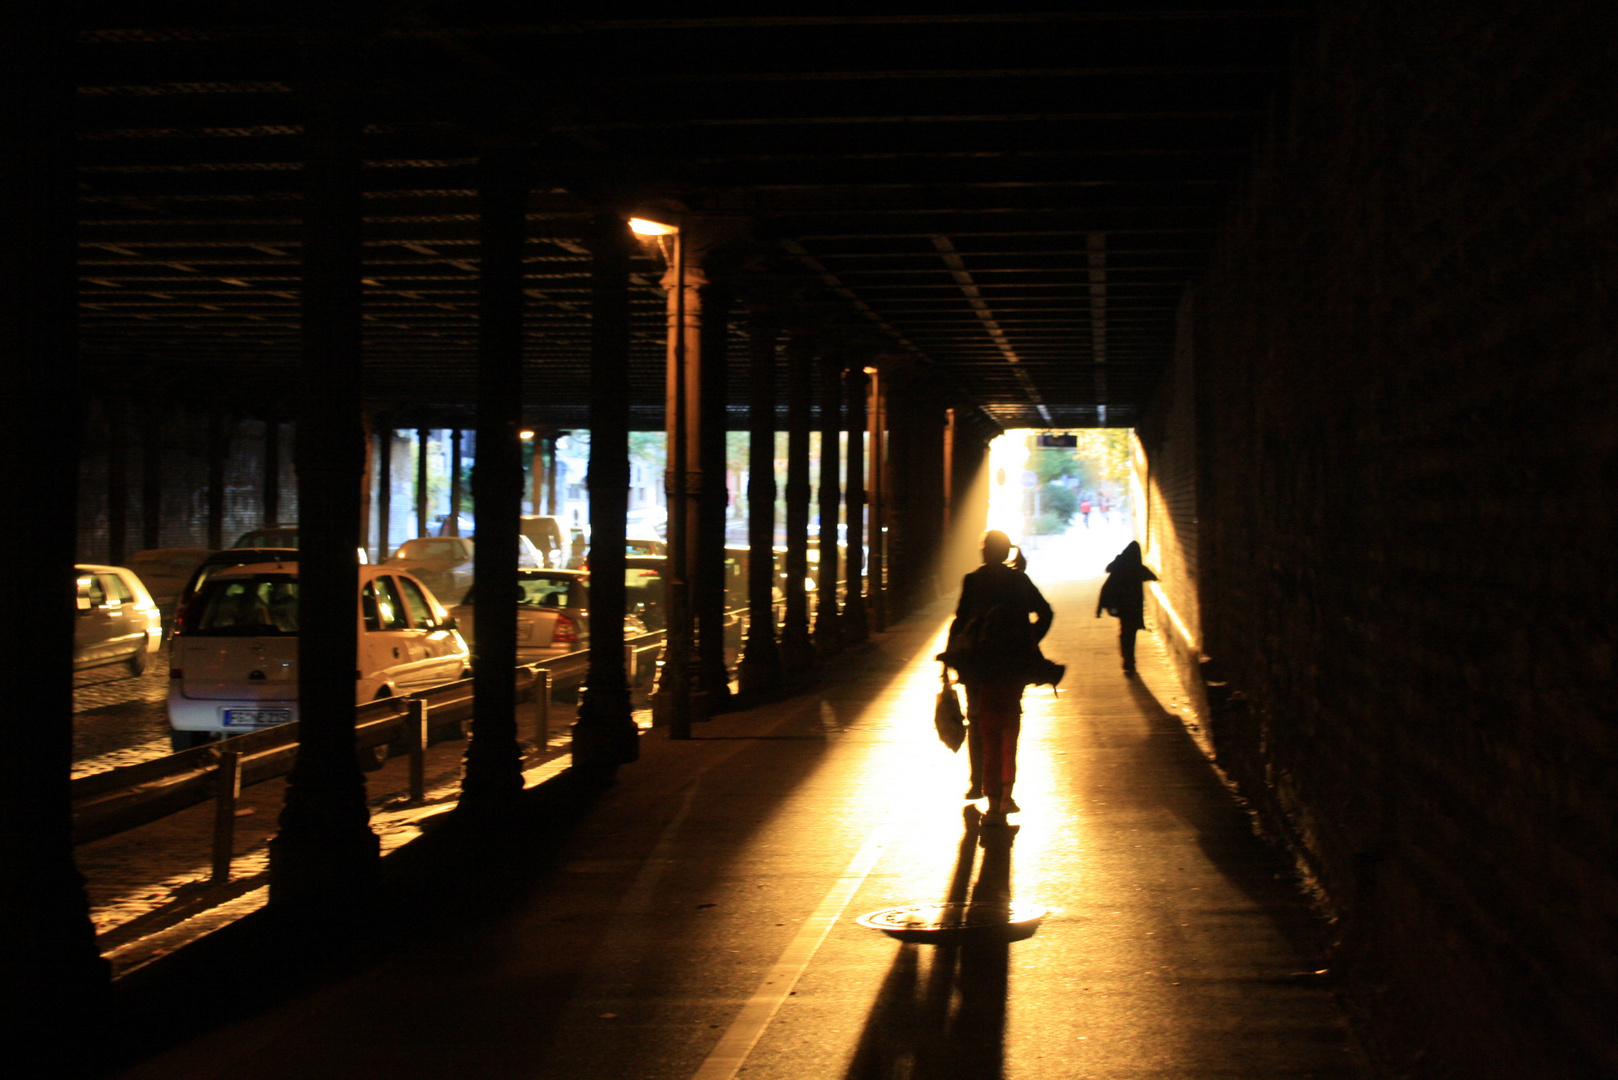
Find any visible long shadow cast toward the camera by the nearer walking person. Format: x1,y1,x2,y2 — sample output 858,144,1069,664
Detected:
845,808,1016,1080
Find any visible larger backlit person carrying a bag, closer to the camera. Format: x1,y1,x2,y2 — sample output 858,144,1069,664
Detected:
938,529,1063,824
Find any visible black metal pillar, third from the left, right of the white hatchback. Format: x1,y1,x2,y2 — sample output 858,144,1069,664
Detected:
460,151,527,816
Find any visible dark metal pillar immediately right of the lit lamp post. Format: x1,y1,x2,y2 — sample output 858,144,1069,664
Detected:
691,280,731,705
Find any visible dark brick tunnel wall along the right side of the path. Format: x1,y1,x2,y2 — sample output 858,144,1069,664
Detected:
1142,2,1618,1078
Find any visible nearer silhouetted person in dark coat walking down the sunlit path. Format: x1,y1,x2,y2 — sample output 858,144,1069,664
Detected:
945,529,1060,824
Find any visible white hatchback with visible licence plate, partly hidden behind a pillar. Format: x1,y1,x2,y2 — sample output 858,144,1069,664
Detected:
168,562,471,750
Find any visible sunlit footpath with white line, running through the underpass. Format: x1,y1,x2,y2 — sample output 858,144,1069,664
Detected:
114,566,1362,1080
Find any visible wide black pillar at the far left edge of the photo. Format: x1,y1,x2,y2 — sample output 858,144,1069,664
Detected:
0,16,110,1077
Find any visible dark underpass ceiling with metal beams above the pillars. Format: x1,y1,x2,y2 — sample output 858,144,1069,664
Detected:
74,3,1301,427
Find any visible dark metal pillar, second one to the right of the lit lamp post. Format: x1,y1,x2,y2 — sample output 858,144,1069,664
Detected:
736,308,781,695
